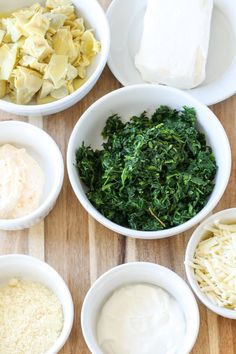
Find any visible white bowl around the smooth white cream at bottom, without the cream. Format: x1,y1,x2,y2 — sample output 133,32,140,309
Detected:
81,262,199,354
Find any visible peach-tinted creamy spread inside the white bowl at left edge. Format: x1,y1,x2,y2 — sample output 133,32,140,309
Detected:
0,144,44,219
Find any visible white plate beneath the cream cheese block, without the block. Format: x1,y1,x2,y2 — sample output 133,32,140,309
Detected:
107,0,236,105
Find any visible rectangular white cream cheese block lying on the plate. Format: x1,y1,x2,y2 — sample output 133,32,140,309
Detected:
135,0,213,89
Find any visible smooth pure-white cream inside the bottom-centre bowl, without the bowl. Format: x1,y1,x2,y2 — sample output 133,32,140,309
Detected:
97,284,185,354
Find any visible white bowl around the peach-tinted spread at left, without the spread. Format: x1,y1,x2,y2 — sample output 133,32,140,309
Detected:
0,121,64,230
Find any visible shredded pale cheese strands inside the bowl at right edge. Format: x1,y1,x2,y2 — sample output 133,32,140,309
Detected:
190,221,236,310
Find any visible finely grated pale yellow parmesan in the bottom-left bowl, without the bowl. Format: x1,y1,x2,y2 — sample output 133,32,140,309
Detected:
0,278,63,354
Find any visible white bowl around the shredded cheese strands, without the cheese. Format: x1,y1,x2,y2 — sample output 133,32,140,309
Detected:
185,208,236,319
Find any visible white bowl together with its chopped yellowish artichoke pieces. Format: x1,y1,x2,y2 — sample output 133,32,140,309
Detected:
0,0,110,116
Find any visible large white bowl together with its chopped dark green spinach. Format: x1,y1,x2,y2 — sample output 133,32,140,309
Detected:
67,85,231,239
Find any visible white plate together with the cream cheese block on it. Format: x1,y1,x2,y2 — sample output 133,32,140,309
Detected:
107,0,236,105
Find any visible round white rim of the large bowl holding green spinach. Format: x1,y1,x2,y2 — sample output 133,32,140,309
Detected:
66,84,231,239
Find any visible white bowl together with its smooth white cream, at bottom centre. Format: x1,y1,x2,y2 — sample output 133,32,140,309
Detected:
81,262,199,354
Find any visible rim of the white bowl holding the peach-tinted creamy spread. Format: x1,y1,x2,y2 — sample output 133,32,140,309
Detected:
0,120,64,230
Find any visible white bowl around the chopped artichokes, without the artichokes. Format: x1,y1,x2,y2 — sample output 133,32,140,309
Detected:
0,0,110,116
